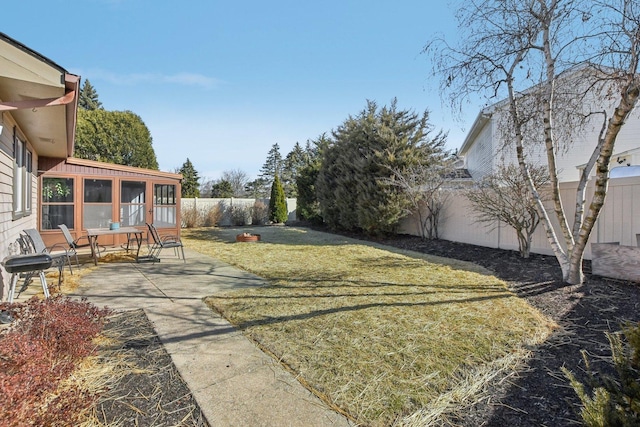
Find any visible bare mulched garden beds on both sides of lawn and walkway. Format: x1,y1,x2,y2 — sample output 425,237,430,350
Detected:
98,236,640,427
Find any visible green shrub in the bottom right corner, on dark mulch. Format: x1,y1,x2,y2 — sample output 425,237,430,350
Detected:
562,323,640,427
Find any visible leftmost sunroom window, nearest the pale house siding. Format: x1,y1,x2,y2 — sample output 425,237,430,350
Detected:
40,177,74,230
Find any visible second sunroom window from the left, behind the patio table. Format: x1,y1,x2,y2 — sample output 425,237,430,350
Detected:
82,179,113,229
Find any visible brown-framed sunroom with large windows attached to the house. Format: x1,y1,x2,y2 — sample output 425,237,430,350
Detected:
38,157,182,251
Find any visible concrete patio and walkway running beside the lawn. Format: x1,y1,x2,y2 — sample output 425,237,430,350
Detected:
69,250,351,427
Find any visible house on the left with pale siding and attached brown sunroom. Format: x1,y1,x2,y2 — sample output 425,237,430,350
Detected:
0,33,182,300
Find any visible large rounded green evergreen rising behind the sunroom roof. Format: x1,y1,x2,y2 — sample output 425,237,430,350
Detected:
74,109,158,170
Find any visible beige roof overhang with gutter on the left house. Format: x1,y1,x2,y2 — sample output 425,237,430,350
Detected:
0,33,80,158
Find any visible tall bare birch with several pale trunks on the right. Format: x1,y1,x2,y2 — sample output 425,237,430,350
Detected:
425,0,640,284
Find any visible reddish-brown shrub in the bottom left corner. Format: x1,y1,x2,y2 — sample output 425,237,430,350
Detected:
0,295,109,425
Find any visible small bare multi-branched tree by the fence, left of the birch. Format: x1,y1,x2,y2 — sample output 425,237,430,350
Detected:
464,165,549,258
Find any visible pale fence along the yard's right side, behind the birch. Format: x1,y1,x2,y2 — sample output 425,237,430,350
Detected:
401,177,640,259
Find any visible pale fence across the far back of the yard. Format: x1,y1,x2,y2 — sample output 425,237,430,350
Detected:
181,197,297,226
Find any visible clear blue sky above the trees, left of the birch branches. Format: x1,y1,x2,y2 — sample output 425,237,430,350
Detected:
0,0,479,180
